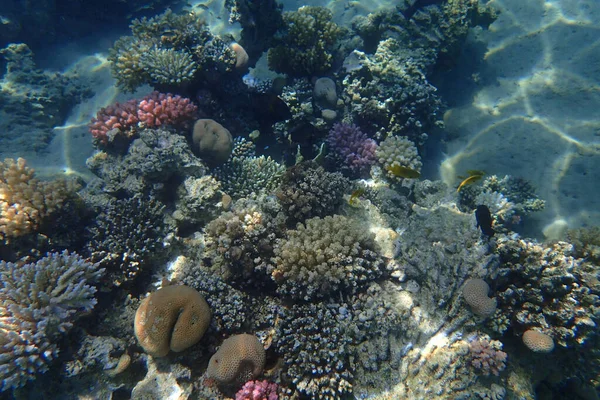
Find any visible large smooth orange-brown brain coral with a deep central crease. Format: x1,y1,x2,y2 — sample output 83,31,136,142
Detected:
134,285,211,357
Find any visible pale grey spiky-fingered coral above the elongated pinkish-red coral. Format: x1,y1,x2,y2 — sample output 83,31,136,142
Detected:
140,47,197,85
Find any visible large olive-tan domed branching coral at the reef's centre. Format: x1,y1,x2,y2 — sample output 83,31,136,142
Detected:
269,215,384,300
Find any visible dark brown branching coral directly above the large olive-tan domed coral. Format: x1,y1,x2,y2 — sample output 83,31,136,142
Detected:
276,162,350,226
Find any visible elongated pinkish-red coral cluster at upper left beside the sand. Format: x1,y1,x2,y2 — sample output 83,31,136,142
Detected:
89,92,198,146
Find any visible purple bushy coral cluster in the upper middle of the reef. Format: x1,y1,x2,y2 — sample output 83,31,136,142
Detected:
327,123,377,174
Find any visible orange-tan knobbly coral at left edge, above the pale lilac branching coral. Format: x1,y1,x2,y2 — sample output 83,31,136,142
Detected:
0,158,79,242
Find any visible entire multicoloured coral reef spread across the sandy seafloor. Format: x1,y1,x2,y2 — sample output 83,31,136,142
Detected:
0,0,600,400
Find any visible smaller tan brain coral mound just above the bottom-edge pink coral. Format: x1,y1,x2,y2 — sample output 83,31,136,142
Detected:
206,333,266,385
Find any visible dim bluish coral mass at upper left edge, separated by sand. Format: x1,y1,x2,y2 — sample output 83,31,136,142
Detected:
0,43,93,154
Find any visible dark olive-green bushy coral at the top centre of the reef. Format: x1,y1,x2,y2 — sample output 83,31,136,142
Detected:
268,6,344,76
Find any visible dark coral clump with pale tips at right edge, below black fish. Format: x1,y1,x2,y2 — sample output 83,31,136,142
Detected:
495,238,600,348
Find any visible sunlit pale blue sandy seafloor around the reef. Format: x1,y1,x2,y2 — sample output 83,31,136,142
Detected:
9,0,600,235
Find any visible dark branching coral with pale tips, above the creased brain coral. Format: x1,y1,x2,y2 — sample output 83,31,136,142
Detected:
87,196,168,286
